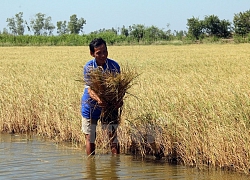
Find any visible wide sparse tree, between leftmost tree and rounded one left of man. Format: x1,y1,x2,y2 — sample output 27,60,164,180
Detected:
30,13,55,35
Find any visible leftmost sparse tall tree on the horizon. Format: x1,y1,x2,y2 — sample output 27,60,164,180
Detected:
6,12,25,35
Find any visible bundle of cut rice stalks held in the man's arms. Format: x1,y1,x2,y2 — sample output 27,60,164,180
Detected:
86,67,138,124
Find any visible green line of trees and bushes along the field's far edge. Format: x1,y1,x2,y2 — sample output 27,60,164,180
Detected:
0,10,250,45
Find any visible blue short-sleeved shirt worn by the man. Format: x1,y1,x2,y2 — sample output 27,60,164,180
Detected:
81,59,120,119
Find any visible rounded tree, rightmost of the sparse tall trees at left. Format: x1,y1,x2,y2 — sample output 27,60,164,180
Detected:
68,14,86,34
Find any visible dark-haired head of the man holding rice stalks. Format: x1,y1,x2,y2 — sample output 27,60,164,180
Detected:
89,38,108,66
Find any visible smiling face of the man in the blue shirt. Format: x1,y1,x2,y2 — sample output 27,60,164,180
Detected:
90,44,108,66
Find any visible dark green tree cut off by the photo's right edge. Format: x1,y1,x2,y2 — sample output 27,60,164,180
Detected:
233,10,250,37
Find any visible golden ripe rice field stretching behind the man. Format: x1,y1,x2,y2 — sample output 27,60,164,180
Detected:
0,44,250,174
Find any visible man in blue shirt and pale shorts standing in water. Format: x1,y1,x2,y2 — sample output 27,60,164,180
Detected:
81,38,122,155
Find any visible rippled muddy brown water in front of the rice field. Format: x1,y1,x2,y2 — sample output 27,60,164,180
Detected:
0,134,249,180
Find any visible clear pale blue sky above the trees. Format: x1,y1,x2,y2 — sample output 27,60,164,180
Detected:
0,0,250,34
